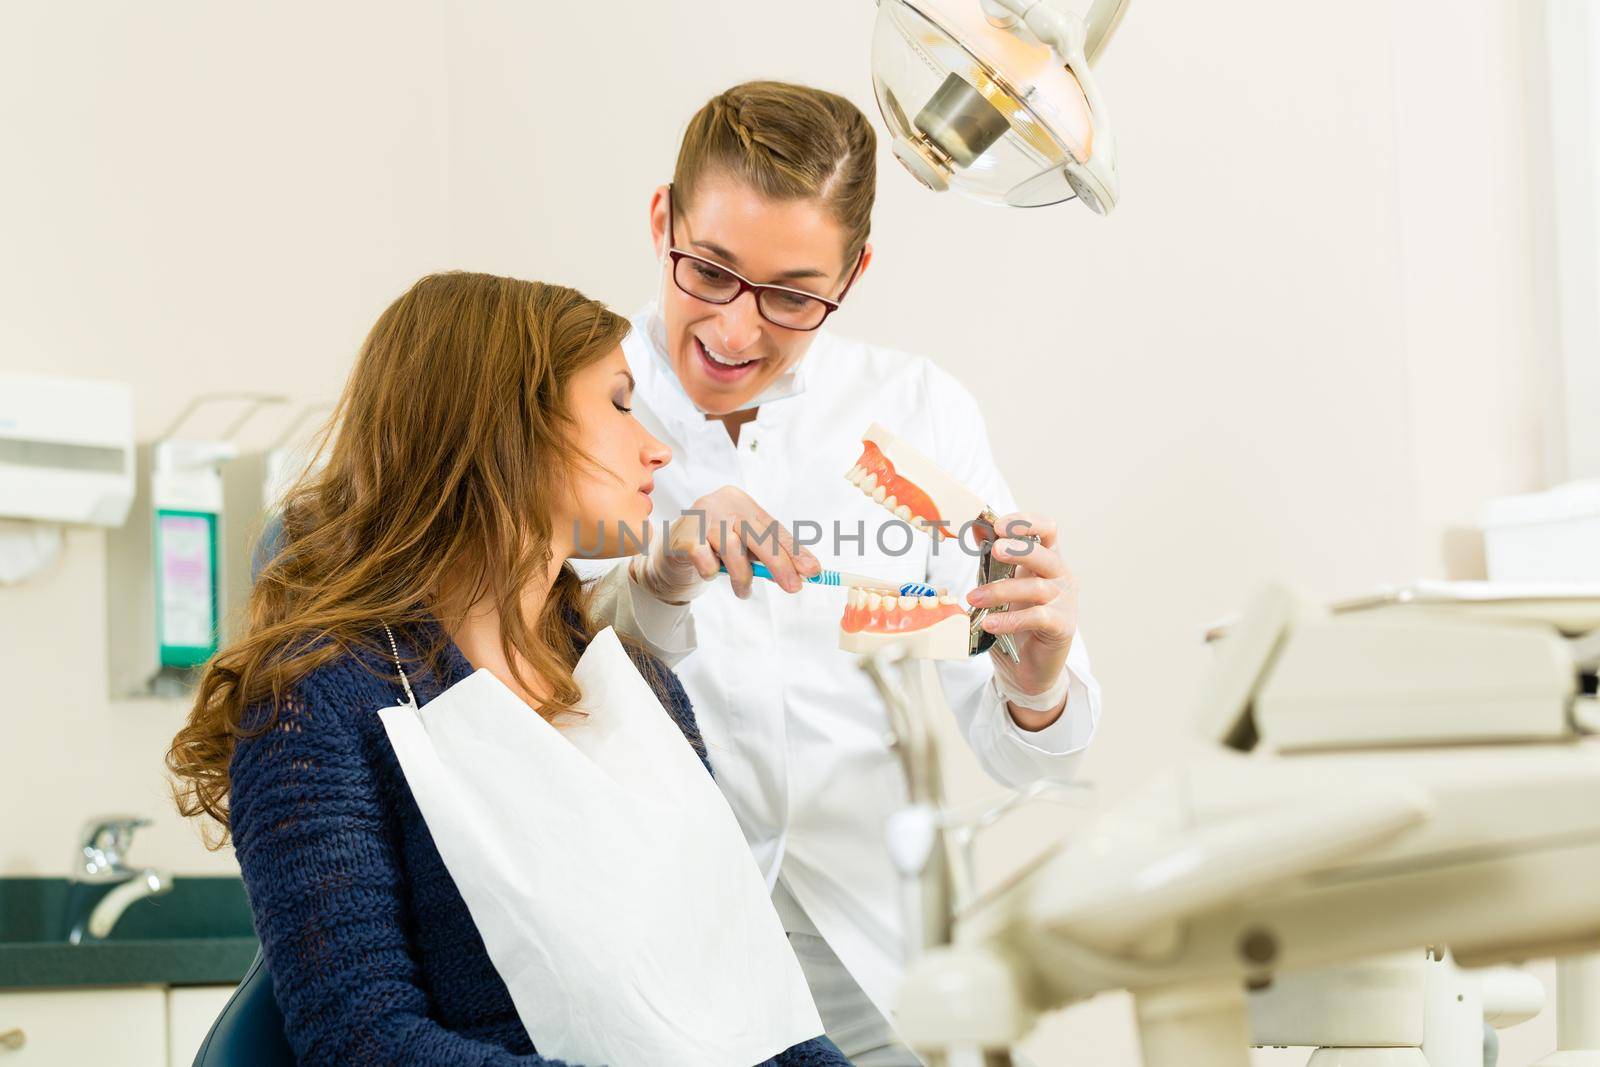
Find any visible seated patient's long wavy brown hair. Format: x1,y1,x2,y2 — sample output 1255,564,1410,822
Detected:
166,274,627,848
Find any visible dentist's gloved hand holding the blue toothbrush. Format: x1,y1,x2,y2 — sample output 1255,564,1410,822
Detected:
629,485,822,603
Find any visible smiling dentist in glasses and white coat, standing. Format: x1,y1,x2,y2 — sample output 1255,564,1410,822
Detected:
585,82,1099,1067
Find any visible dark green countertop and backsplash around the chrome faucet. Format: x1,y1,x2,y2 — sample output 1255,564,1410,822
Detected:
0,875,258,989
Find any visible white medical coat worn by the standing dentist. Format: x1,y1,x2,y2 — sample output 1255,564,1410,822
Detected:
586,309,1099,1014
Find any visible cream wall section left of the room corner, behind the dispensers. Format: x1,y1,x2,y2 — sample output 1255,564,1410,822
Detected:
0,2,448,873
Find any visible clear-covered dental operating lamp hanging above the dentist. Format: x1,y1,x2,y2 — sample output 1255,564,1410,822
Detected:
872,0,1128,214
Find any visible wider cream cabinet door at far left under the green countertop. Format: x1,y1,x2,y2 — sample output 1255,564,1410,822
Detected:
0,987,166,1067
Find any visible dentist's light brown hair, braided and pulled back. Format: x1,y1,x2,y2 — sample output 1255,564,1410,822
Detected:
672,82,877,270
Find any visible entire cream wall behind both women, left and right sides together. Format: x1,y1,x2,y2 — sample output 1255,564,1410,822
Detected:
0,0,1550,1065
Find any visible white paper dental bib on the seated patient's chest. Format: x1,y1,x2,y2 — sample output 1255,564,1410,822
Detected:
379,629,822,1067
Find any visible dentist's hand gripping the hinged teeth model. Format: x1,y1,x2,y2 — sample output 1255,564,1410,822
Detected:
966,512,1078,729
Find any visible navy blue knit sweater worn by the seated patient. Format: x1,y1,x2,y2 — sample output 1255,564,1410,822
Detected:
230,627,850,1067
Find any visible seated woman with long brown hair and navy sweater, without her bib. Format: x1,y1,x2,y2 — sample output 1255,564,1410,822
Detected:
168,274,846,1065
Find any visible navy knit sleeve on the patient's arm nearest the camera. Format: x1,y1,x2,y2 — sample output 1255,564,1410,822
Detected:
230,675,582,1067
